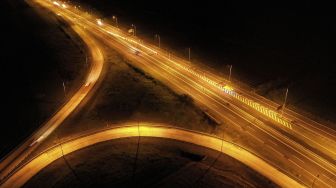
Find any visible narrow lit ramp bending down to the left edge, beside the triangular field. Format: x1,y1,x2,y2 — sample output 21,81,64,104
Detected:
0,2,104,184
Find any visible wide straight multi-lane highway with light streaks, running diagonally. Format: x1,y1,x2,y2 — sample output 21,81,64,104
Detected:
0,0,336,187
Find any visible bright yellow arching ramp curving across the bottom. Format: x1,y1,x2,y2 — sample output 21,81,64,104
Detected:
1,123,303,187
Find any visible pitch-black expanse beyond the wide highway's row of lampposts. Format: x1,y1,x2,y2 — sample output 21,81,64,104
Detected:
77,0,336,119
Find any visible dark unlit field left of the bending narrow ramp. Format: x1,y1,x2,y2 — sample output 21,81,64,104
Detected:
0,1,85,158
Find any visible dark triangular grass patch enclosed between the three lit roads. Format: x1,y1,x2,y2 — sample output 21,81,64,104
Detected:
36,45,218,153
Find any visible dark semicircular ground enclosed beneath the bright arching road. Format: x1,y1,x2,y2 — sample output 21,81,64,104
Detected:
24,137,276,188
